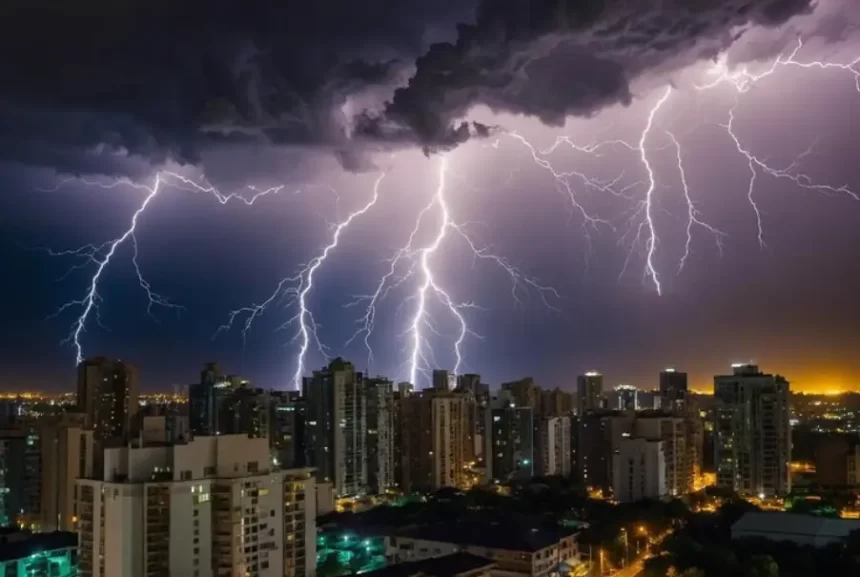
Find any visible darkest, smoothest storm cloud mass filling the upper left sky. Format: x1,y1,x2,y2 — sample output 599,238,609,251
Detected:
0,0,474,174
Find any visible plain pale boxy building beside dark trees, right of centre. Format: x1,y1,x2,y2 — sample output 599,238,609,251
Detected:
612,437,668,503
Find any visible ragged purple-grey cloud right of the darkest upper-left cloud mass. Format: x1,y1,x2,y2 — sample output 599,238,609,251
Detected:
363,0,813,149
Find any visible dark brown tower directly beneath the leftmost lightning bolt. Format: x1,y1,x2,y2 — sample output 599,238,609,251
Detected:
78,357,139,439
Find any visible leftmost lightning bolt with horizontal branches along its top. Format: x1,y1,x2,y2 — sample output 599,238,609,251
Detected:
47,171,302,364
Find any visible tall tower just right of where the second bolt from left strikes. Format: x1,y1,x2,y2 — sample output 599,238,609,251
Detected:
304,358,367,497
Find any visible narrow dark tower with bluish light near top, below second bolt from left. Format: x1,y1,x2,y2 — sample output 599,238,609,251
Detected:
269,391,306,469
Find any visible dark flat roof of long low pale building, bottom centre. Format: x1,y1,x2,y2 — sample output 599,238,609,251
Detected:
397,521,576,553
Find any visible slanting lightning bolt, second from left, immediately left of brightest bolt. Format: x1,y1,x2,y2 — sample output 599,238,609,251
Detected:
216,172,386,390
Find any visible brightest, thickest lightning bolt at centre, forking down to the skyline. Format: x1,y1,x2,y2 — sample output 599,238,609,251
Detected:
347,156,560,384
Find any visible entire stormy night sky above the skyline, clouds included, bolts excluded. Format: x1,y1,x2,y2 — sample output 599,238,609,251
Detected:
0,0,860,391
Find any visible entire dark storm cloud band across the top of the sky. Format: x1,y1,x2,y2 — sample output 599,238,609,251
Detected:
0,0,811,175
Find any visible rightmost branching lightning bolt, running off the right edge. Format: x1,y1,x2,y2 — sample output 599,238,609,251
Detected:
696,36,860,248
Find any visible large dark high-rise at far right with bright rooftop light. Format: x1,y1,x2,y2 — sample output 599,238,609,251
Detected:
714,364,791,498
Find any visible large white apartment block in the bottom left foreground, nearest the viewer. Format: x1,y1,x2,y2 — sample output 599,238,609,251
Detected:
77,435,316,577
